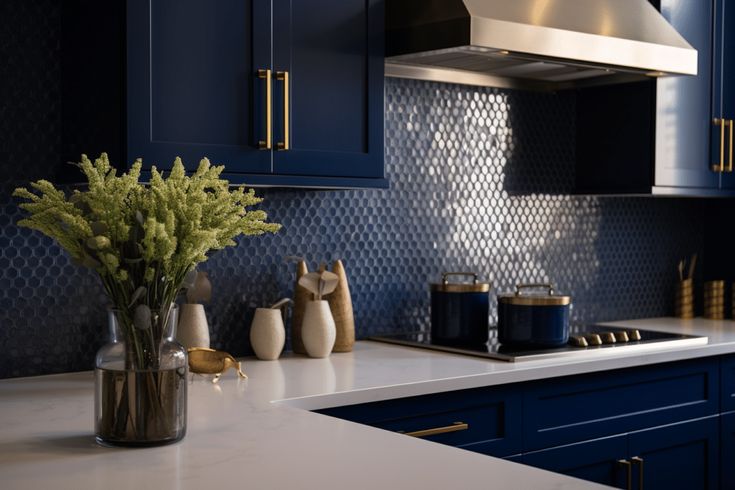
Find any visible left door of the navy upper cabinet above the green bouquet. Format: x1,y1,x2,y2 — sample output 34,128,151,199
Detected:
127,0,271,173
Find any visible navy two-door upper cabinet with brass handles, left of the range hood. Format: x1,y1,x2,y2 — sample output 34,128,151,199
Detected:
127,0,386,187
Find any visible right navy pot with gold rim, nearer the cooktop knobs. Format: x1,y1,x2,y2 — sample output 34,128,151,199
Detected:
498,284,571,347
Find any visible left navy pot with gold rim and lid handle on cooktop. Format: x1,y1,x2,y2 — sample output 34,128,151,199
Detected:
431,272,490,345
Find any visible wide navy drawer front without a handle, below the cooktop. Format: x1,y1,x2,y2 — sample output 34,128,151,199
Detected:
523,359,720,451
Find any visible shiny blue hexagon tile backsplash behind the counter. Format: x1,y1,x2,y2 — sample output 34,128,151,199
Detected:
0,75,704,377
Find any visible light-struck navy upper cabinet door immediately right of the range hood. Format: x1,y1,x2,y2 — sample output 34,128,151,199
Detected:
655,0,719,189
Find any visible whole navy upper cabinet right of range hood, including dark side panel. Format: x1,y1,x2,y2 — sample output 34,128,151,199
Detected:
577,0,735,197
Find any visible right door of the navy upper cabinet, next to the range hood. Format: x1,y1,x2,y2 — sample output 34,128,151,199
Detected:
273,0,383,178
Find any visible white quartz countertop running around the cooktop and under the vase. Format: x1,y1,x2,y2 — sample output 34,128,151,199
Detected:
0,318,735,490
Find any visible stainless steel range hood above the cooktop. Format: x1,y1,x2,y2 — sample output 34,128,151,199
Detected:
386,0,697,90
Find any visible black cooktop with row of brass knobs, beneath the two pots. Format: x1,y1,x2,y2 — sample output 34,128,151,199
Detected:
370,325,708,362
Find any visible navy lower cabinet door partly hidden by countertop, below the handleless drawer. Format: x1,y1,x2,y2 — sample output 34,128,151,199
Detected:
522,435,632,488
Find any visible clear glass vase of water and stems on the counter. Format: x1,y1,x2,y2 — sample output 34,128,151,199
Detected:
95,305,188,446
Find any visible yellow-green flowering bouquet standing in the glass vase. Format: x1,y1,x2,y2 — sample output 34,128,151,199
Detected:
14,153,280,369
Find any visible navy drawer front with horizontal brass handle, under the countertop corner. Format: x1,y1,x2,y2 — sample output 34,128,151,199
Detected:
318,388,521,456
